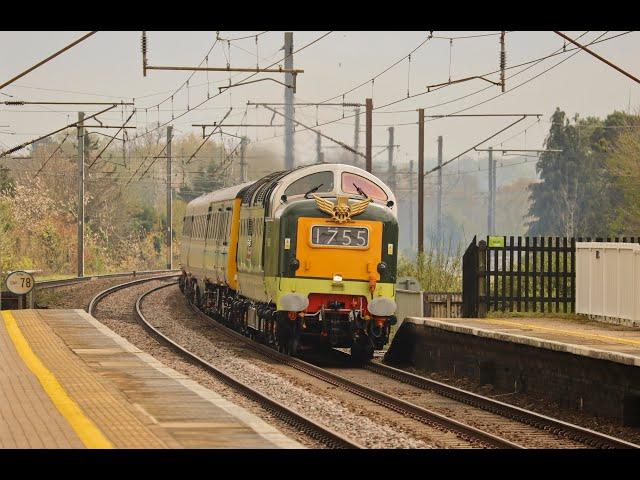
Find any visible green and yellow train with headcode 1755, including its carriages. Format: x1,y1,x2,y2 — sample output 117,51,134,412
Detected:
180,164,398,359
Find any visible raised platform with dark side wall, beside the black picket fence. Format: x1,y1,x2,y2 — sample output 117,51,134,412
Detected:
385,317,640,426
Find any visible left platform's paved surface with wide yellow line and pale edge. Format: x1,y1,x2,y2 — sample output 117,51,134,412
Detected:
0,310,302,448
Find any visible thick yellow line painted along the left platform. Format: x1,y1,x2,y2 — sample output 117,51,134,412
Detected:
2,311,113,448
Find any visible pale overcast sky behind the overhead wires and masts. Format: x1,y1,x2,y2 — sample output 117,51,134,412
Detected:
0,31,640,176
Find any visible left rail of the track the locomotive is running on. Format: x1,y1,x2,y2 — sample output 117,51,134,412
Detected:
175,288,524,449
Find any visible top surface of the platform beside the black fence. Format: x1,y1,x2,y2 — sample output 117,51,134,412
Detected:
405,317,640,366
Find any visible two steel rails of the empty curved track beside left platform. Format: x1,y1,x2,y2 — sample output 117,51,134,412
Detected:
87,275,363,449
